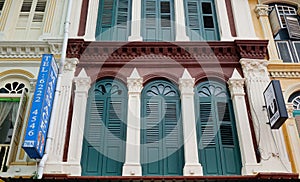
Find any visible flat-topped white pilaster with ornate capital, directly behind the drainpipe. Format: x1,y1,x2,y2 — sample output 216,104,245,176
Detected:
44,58,78,173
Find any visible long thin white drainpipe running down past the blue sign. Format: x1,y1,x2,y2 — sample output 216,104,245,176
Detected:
37,0,73,179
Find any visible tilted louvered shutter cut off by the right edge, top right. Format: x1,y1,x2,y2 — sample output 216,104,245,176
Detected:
285,15,300,39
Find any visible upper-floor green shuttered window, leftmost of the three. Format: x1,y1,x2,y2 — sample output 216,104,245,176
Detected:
96,0,131,41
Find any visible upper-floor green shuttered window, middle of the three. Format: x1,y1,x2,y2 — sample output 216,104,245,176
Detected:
142,0,175,41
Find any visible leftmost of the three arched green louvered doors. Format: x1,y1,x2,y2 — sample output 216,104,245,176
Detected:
81,79,127,176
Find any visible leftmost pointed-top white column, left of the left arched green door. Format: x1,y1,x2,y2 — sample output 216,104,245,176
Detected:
64,68,91,176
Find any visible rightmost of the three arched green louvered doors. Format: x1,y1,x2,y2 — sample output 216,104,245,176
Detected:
195,81,241,175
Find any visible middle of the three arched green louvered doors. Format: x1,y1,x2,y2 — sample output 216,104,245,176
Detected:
141,80,184,176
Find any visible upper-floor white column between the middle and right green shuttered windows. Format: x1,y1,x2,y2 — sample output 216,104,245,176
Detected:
174,0,189,41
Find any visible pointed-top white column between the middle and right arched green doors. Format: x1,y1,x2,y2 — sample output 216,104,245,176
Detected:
179,69,203,176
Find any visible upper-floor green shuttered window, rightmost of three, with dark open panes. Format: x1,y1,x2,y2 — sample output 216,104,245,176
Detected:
185,0,219,41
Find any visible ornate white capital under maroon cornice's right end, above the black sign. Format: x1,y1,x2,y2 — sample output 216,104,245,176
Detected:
240,58,269,80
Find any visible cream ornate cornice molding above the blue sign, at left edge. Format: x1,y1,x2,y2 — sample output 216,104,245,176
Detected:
0,41,62,58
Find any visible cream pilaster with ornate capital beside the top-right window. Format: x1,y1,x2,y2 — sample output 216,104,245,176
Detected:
255,4,282,62
